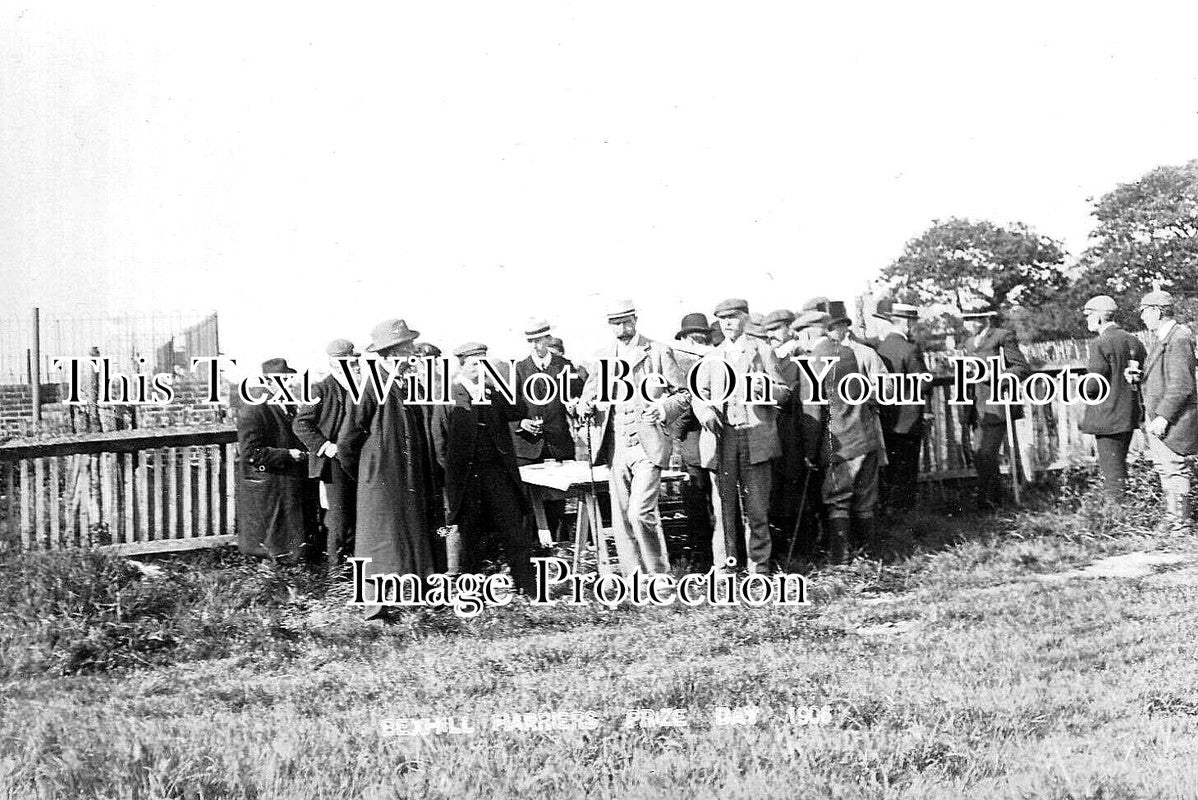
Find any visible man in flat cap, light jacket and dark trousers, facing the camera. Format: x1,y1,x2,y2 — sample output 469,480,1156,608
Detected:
691,298,791,572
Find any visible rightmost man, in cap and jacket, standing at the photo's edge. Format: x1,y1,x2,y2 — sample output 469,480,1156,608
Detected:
1132,290,1198,533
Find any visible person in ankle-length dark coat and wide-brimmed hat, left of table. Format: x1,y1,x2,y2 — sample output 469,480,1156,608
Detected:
337,320,436,619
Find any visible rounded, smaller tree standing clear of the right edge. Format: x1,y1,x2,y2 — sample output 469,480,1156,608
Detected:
882,218,1069,309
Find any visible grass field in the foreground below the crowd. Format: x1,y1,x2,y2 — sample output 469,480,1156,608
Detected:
0,462,1198,800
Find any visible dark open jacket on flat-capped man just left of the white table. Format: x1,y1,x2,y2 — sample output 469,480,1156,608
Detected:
432,381,532,525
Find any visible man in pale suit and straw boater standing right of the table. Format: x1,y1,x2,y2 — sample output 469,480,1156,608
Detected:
579,301,690,575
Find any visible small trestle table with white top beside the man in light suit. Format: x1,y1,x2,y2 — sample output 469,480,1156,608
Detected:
520,461,686,574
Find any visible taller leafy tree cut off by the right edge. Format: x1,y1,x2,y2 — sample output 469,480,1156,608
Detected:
1077,159,1198,309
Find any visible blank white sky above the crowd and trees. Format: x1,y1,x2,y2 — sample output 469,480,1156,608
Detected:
0,0,1198,376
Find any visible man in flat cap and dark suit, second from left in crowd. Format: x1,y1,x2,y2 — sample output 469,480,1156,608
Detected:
292,339,361,568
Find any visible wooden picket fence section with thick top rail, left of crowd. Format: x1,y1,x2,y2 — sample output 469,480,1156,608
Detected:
0,428,237,553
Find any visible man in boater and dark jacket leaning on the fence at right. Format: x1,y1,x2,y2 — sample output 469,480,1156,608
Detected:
961,308,1031,511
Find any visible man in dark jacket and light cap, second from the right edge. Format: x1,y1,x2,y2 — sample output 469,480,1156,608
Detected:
1077,295,1145,503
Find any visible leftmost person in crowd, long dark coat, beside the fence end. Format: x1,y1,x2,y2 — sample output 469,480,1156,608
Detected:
237,358,317,563
